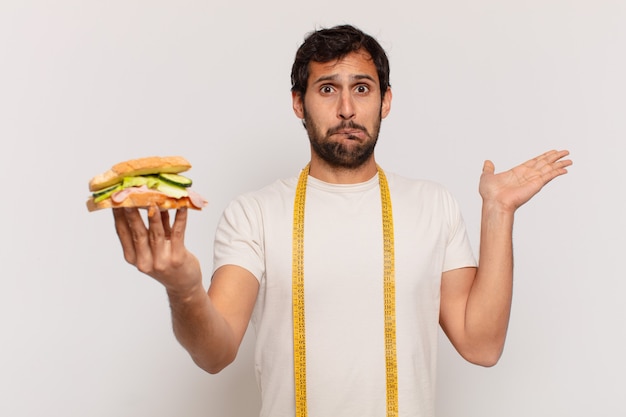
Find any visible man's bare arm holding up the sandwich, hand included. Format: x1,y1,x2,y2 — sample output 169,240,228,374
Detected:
113,208,258,373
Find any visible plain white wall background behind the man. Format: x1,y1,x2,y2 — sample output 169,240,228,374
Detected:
0,0,626,417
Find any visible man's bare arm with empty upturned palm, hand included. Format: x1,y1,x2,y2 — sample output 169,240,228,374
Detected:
440,151,572,366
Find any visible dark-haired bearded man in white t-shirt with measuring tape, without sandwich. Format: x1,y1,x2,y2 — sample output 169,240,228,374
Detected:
114,26,571,417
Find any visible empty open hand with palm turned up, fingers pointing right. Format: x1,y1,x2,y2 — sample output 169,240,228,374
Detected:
479,150,572,211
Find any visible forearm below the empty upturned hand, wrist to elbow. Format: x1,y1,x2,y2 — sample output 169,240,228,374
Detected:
465,203,514,360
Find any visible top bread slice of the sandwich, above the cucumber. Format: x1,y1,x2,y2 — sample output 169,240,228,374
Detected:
89,156,191,191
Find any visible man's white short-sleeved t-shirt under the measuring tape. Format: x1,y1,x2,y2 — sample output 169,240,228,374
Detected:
214,173,476,417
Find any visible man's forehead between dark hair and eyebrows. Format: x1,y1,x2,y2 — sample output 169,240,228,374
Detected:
308,51,378,84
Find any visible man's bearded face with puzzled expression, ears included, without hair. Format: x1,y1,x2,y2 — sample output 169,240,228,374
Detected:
293,52,391,168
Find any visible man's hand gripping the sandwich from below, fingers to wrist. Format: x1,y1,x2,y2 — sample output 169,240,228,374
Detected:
113,207,202,293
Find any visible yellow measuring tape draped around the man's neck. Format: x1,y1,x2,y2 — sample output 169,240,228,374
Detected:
292,165,398,417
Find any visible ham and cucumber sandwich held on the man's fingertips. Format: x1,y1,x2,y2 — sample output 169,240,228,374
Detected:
87,156,207,211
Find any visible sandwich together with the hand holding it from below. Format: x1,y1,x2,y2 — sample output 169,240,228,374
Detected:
87,156,206,292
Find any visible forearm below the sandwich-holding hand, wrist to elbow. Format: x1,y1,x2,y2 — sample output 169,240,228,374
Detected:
168,285,238,373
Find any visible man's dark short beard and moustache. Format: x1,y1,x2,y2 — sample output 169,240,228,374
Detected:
303,109,382,169
